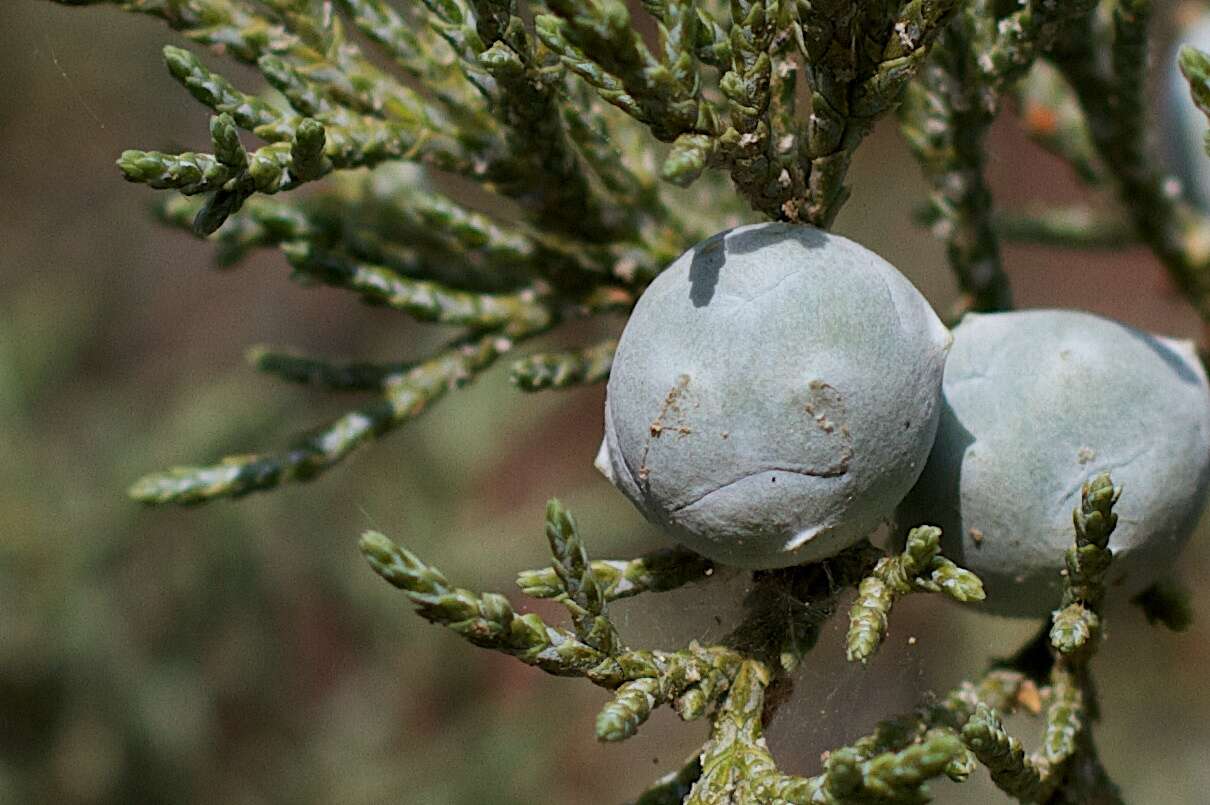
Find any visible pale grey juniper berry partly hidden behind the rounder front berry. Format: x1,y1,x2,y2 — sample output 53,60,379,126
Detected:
898,310,1210,617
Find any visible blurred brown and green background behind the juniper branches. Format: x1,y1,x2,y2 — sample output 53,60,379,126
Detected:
0,0,1210,805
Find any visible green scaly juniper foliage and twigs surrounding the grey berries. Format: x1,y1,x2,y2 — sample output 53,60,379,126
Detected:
35,0,1210,805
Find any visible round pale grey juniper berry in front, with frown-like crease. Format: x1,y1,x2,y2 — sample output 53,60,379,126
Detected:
598,223,950,568
